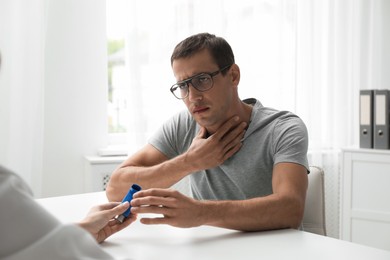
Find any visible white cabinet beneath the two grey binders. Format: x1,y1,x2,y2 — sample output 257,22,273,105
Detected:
340,148,390,250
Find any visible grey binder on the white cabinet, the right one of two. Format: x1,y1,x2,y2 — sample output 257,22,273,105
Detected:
374,89,390,149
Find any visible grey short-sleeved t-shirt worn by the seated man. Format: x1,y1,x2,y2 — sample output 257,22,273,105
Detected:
149,99,309,200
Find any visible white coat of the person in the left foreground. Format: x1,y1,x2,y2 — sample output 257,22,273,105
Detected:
0,166,113,260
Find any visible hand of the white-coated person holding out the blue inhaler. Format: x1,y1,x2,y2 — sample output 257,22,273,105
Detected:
78,202,137,243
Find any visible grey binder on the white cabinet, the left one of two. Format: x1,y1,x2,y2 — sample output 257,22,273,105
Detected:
360,89,374,148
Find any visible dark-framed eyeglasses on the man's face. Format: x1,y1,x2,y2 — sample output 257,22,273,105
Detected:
171,65,232,99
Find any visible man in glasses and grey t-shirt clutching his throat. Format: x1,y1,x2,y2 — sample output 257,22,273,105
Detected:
107,33,309,231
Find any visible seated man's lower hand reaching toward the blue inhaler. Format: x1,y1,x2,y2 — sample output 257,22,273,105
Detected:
131,189,205,228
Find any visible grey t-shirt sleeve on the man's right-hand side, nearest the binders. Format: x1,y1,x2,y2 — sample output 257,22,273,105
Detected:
273,116,309,171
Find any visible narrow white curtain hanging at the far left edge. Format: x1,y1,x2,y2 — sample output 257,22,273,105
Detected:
0,0,45,193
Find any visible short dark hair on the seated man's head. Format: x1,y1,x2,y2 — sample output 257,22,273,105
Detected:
171,33,234,74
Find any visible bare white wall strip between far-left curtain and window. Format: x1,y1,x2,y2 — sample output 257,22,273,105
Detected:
42,0,107,195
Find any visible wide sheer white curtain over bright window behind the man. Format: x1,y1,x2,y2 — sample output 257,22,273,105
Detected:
110,0,390,237
